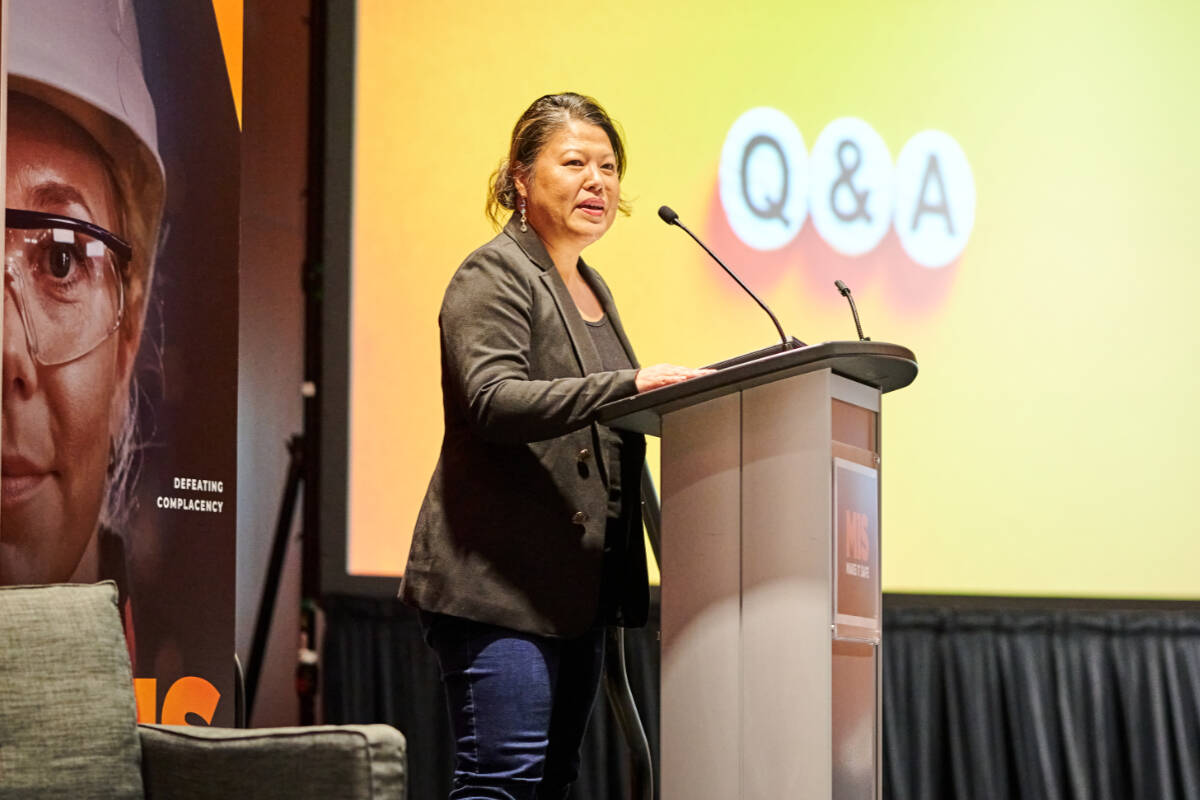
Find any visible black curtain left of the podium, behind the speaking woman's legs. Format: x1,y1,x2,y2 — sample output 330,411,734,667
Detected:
322,596,659,800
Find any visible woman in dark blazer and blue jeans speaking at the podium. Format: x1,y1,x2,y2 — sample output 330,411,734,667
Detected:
401,94,706,799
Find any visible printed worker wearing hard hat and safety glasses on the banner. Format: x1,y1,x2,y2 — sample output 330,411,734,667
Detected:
0,2,164,618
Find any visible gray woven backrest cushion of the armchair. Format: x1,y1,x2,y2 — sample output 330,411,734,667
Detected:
0,581,142,799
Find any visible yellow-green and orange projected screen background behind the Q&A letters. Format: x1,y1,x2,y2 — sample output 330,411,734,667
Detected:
348,0,1200,597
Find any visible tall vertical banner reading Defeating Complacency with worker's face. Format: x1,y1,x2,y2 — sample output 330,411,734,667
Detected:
0,0,240,724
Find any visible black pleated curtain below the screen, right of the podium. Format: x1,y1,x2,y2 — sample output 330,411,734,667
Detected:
883,608,1200,800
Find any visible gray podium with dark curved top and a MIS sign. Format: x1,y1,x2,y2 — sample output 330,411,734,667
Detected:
599,342,917,800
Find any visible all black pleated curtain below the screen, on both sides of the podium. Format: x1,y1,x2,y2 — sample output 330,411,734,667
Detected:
323,595,1200,800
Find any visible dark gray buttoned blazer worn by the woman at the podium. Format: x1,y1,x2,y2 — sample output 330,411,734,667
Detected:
401,214,649,636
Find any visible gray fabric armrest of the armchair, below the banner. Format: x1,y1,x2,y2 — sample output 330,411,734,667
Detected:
138,724,406,800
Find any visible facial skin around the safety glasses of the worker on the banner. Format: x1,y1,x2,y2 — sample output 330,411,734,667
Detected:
0,95,137,584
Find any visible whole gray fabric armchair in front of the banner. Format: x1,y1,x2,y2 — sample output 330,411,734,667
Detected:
0,582,404,800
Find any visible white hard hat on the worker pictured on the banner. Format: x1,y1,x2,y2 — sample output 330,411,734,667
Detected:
5,0,164,304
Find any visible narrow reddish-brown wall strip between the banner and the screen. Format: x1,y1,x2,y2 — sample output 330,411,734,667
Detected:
236,0,308,727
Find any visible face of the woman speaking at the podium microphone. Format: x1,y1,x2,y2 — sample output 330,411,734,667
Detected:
516,120,620,255
